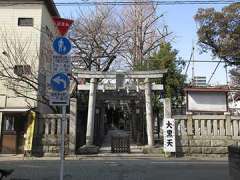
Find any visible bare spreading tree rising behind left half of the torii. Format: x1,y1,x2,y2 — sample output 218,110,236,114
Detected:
70,6,128,71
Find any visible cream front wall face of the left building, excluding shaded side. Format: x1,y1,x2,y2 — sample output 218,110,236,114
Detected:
0,4,42,108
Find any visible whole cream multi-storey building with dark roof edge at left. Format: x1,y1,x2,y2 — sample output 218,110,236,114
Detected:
0,0,59,153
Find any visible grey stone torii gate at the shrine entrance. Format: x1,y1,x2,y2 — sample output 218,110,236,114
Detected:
75,70,167,153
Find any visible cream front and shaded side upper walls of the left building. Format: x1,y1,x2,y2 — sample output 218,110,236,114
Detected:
0,3,56,111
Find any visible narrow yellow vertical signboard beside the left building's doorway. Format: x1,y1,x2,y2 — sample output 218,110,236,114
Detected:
24,111,36,152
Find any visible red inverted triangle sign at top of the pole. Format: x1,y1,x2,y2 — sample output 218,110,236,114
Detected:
53,17,73,36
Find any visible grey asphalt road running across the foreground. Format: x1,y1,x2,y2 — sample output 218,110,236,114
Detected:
0,159,230,180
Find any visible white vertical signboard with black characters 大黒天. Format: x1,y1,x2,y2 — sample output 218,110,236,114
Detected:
163,118,176,152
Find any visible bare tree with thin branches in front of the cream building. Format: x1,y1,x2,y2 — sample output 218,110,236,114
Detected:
0,30,56,111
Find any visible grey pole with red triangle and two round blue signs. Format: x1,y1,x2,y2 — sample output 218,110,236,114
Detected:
50,17,73,180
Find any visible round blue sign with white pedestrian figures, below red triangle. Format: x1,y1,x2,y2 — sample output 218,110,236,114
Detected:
53,37,72,55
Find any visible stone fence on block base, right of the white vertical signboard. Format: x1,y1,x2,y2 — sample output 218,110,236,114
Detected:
173,113,240,156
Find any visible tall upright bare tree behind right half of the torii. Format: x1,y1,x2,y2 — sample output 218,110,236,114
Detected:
124,0,171,67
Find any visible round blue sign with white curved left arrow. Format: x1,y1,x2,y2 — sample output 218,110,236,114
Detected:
50,73,70,92
